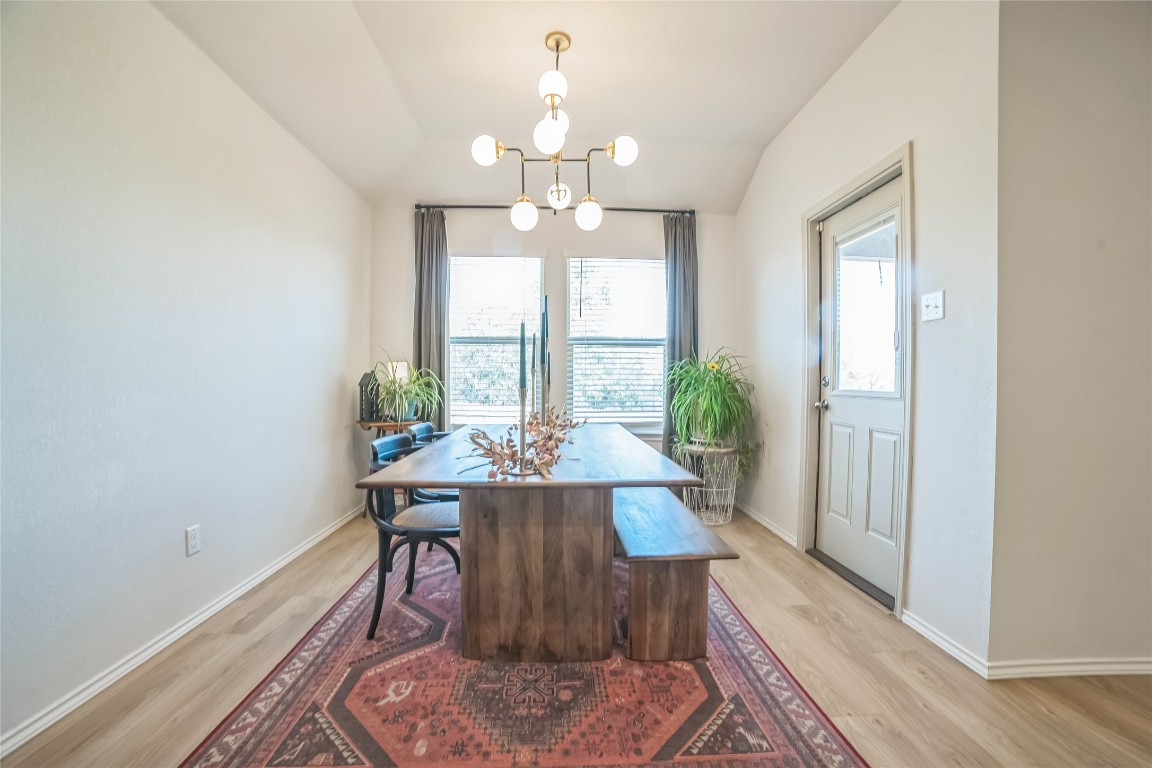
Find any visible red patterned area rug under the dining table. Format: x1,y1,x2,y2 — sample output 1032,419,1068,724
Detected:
183,549,865,768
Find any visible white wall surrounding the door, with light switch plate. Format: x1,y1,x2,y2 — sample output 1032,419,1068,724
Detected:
737,2,999,659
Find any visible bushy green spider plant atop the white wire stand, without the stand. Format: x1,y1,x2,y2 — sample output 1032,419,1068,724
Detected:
667,349,756,474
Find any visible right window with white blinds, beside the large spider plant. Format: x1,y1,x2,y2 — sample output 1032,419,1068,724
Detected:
568,259,668,426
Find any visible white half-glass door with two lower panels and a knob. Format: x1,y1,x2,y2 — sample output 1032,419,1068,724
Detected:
813,178,905,607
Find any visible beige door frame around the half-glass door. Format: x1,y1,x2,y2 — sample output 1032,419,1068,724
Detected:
796,142,915,618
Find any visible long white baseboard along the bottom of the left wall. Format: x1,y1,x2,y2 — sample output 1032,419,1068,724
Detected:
0,504,363,758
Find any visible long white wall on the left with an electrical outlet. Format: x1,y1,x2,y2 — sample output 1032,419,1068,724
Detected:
0,3,371,746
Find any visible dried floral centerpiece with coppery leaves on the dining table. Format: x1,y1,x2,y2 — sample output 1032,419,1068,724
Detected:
468,408,588,480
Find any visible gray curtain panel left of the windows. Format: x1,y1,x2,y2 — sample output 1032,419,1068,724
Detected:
412,208,448,429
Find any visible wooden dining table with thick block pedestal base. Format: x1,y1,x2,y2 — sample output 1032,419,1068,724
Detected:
356,424,703,661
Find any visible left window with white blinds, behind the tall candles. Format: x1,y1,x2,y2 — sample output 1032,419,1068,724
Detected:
448,256,540,426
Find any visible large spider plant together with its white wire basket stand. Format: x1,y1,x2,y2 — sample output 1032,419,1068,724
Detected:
667,349,759,525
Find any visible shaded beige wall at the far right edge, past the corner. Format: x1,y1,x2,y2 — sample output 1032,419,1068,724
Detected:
990,2,1152,671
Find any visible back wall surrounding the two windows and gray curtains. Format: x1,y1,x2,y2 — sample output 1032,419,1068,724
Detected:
372,202,738,437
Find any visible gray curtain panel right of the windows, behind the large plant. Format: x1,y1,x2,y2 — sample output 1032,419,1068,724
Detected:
664,213,699,456
